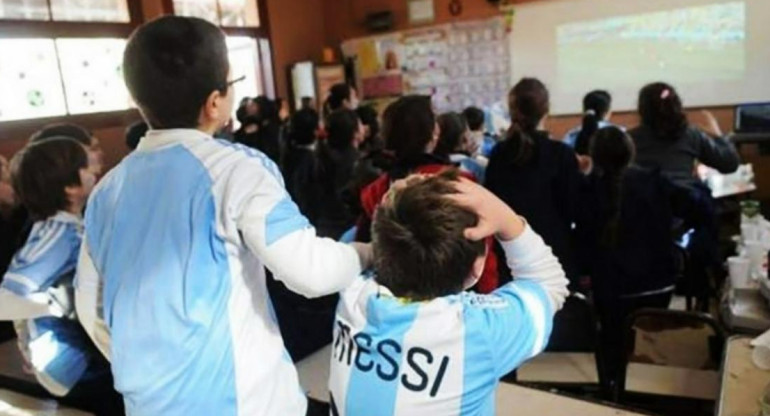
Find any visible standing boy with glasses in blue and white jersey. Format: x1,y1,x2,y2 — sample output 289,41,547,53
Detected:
76,16,366,416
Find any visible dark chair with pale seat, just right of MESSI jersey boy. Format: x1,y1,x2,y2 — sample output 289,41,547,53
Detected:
506,293,607,394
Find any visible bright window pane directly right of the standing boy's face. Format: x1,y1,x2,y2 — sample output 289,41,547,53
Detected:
227,36,262,128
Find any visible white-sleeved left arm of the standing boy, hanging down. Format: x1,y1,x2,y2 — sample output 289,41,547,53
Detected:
75,238,110,360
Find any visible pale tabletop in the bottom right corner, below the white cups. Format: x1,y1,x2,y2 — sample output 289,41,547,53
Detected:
717,336,770,416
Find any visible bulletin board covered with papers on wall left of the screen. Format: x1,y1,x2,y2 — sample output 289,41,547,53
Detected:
342,17,511,112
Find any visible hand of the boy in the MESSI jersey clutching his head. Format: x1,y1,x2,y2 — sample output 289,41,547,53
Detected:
448,178,525,241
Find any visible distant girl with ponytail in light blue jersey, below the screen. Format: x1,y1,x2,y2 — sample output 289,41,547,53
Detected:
564,90,617,155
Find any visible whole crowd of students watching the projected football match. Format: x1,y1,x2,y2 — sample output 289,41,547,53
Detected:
0,17,739,415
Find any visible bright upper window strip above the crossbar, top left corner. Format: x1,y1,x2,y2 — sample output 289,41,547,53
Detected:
0,0,131,23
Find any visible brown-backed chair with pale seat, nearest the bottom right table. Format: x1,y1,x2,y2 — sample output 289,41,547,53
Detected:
613,309,725,414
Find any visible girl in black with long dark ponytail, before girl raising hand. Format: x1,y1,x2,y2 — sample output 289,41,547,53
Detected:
576,127,707,386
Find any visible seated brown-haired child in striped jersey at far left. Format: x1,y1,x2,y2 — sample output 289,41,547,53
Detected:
0,138,122,414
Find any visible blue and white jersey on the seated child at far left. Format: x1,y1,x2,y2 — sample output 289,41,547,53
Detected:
0,211,98,396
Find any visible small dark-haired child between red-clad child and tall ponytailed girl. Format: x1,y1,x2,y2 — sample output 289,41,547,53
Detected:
433,113,486,183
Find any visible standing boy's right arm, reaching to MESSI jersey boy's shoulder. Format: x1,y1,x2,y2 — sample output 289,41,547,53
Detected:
234,160,370,297
